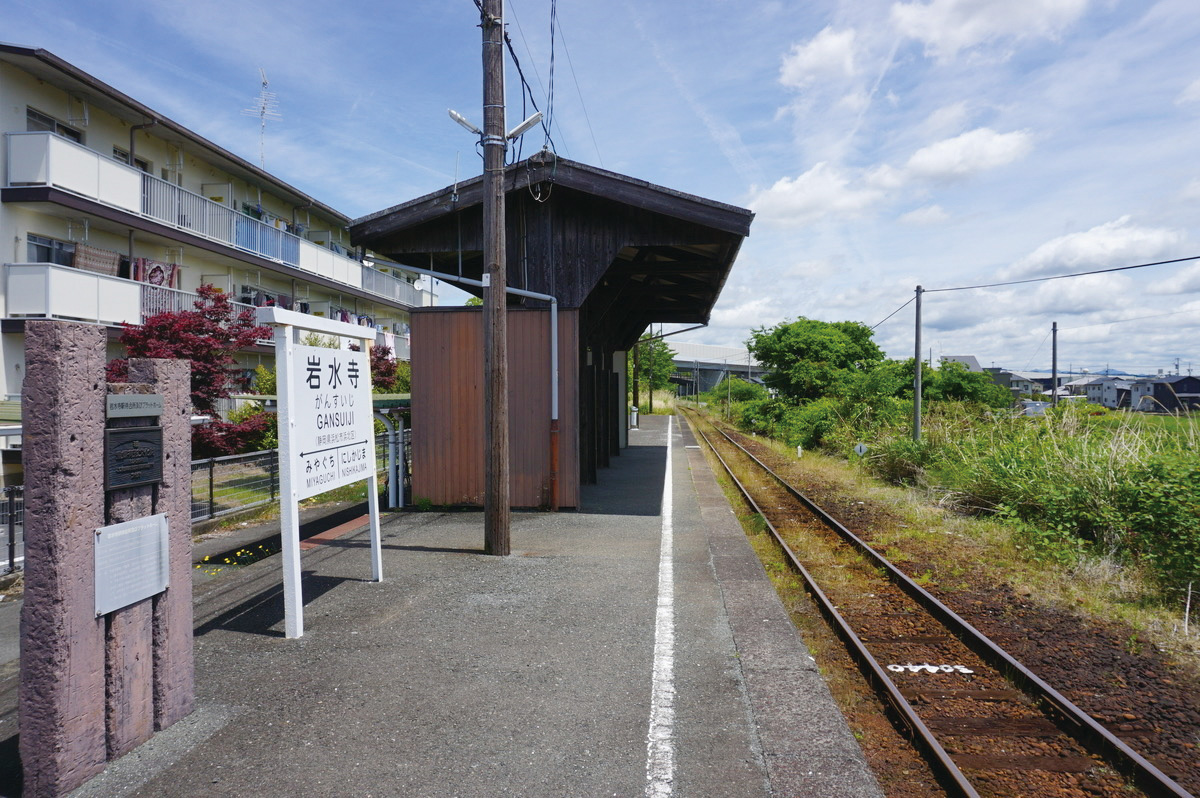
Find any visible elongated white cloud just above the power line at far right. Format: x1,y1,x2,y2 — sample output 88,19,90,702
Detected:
1004,216,1184,277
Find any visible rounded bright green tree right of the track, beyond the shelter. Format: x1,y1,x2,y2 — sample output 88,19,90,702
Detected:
748,316,883,402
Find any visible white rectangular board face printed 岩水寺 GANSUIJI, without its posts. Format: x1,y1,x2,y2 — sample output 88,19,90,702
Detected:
290,344,374,499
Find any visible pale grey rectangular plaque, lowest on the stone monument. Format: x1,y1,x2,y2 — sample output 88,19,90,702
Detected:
96,512,169,616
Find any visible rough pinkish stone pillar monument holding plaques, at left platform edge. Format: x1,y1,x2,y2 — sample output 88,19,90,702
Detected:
20,322,194,797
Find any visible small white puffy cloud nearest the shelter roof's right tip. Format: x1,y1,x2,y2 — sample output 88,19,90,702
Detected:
750,162,884,227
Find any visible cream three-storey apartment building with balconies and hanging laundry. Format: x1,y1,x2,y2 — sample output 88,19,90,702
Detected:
0,44,436,402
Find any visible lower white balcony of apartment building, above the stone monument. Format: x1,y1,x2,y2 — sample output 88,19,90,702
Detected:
4,263,254,326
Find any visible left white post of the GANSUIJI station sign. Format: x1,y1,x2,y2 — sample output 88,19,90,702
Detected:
275,324,304,637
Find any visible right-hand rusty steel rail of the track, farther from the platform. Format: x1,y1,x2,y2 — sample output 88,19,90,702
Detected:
706,412,1195,798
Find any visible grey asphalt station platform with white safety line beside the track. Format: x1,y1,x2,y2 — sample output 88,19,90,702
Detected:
2,416,881,797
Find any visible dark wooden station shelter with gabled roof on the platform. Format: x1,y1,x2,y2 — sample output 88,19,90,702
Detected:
350,151,754,508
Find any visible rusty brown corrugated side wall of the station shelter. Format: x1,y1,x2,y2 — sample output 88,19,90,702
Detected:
412,307,580,508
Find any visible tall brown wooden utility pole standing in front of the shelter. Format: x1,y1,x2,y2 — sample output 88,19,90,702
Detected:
480,0,511,557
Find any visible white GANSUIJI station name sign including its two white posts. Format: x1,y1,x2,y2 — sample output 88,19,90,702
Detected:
258,307,383,637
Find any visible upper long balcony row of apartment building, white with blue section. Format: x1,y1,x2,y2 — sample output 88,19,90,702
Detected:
5,132,433,307
